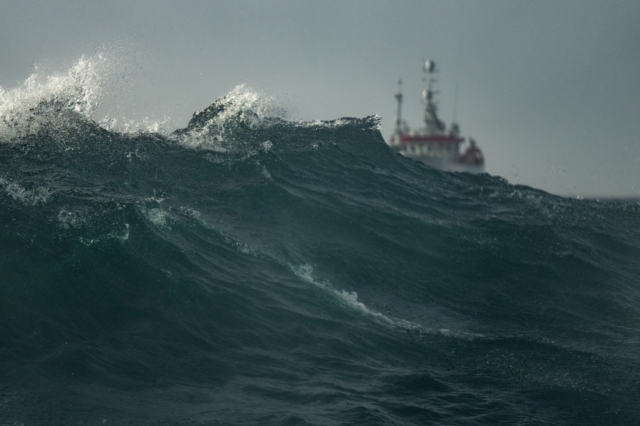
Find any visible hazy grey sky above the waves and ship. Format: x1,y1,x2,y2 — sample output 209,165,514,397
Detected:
0,0,640,197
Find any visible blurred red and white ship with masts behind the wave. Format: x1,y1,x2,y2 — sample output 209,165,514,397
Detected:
388,61,484,173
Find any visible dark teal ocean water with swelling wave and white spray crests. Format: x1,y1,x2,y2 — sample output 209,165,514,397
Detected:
0,60,640,426
